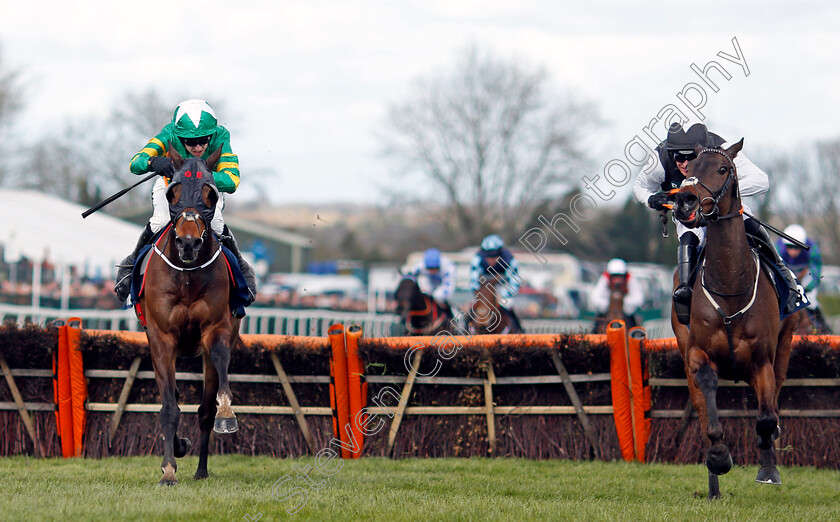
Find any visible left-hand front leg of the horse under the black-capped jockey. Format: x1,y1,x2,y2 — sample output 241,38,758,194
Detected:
686,349,732,499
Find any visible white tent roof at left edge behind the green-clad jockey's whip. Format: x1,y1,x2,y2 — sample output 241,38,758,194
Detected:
0,189,143,277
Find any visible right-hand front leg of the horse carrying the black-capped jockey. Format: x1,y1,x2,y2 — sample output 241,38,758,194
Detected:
751,361,782,486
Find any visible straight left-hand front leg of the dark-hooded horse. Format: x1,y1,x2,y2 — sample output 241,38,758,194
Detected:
152,348,181,486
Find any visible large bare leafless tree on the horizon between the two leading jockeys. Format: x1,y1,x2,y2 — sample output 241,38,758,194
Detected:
382,46,599,242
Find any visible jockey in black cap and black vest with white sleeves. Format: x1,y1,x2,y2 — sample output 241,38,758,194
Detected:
633,123,800,324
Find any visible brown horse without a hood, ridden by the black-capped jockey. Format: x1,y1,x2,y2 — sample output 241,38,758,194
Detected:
671,139,799,498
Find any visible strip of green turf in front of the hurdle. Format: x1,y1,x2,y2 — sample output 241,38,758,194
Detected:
0,455,840,522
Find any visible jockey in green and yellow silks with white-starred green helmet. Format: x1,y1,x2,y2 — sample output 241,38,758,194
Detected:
114,100,257,303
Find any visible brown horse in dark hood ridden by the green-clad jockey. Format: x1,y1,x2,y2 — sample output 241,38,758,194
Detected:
139,149,239,485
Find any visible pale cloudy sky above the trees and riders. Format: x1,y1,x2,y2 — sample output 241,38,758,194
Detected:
0,0,840,203
